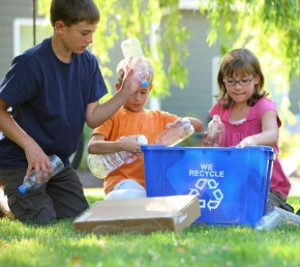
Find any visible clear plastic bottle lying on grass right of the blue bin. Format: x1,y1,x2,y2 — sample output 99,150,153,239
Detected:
255,207,300,231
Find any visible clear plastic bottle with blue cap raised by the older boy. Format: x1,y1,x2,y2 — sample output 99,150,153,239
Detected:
121,38,149,87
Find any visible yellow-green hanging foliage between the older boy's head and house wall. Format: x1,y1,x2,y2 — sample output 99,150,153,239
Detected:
39,0,189,99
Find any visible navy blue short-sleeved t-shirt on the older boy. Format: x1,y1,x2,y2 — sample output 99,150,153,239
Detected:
0,38,107,168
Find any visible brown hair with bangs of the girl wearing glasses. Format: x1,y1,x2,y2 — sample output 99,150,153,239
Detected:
217,48,268,108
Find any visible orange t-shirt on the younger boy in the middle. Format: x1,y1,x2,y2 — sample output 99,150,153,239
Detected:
93,107,179,194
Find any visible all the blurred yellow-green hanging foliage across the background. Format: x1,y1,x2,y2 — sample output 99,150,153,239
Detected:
38,0,300,171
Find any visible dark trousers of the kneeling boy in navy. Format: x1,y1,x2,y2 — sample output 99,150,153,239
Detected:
0,166,89,224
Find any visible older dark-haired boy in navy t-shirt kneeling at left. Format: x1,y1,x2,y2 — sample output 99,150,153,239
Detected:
0,0,138,224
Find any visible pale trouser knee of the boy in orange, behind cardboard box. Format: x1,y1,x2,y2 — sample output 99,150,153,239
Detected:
105,179,146,200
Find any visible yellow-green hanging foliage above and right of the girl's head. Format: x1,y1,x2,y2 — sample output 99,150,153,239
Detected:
200,0,300,122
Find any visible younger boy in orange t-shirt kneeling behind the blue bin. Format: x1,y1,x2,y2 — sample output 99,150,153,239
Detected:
88,59,204,199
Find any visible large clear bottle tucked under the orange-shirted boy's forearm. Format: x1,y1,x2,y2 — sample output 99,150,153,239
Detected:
87,135,148,178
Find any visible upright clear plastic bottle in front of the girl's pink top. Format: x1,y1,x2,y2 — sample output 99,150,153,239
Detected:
207,115,225,147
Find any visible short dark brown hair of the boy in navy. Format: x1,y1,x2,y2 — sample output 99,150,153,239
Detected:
50,0,100,27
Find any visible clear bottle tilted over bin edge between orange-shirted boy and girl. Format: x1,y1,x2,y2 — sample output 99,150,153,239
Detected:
155,118,195,146
